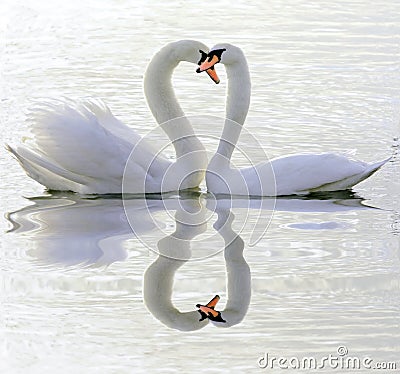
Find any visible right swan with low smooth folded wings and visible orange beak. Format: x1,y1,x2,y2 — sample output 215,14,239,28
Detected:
197,43,390,196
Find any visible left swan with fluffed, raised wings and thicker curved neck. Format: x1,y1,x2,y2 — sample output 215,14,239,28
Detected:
6,40,208,194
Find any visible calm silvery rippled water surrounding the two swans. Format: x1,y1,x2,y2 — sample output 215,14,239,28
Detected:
0,0,400,373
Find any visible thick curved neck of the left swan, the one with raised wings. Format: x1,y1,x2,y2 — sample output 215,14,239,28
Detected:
144,40,205,157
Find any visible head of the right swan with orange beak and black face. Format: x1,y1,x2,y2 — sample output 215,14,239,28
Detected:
196,43,244,84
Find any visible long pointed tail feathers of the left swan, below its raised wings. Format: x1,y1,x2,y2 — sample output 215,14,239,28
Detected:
6,144,88,191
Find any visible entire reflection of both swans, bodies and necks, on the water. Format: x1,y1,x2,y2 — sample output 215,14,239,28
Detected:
7,192,382,331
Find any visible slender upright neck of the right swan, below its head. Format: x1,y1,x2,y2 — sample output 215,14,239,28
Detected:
217,48,251,160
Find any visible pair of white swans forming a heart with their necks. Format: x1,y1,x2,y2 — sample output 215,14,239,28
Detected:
8,40,388,196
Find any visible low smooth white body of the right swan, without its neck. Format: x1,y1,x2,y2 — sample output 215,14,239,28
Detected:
206,149,387,196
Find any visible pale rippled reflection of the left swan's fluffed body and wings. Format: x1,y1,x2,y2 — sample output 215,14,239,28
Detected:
8,193,171,266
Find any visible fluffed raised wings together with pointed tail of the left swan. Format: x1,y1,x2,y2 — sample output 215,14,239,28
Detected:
9,102,165,193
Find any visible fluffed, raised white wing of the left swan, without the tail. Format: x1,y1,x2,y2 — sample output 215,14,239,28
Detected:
32,103,131,178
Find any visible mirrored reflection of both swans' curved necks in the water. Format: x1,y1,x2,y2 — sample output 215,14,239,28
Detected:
143,200,251,331
